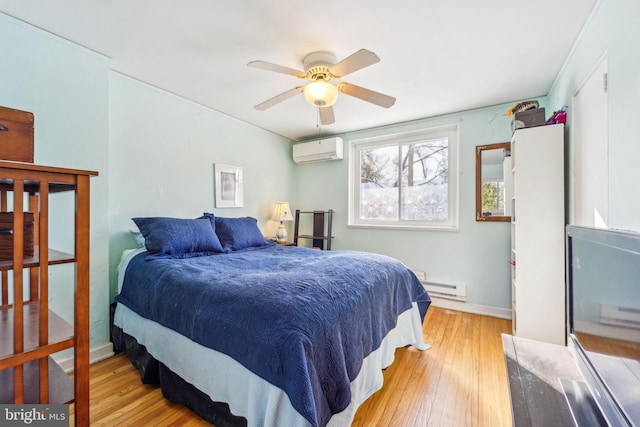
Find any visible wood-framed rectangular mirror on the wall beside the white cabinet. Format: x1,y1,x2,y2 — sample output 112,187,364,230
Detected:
476,142,512,221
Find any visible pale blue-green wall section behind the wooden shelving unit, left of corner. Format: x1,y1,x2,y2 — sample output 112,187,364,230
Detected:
0,14,109,347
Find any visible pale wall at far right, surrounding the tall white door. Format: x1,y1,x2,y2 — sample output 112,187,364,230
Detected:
549,0,640,231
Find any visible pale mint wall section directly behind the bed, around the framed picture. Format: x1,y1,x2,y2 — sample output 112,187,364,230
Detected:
109,72,295,295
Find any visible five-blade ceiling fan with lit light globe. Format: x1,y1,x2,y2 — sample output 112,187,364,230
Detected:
247,49,396,125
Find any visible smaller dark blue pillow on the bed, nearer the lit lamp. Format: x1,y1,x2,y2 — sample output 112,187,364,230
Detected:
210,214,271,251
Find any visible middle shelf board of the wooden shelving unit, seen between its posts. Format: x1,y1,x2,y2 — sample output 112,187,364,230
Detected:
0,302,74,362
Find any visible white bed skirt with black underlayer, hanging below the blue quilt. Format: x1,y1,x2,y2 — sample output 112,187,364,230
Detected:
112,303,430,427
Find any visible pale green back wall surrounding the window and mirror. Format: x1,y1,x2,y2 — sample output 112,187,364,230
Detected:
291,103,528,308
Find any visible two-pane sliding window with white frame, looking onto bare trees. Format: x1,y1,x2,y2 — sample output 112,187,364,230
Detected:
349,126,458,229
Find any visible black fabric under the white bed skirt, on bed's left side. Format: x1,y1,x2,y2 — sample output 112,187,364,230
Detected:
111,324,247,427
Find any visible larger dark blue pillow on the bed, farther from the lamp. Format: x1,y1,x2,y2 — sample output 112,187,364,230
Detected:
133,217,225,259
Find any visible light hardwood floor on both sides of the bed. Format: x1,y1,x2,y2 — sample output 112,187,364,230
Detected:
71,307,512,427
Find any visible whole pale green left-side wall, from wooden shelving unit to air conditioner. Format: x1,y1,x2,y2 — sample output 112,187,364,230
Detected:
0,14,295,357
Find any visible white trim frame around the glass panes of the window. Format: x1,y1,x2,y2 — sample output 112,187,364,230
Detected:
347,124,460,231
